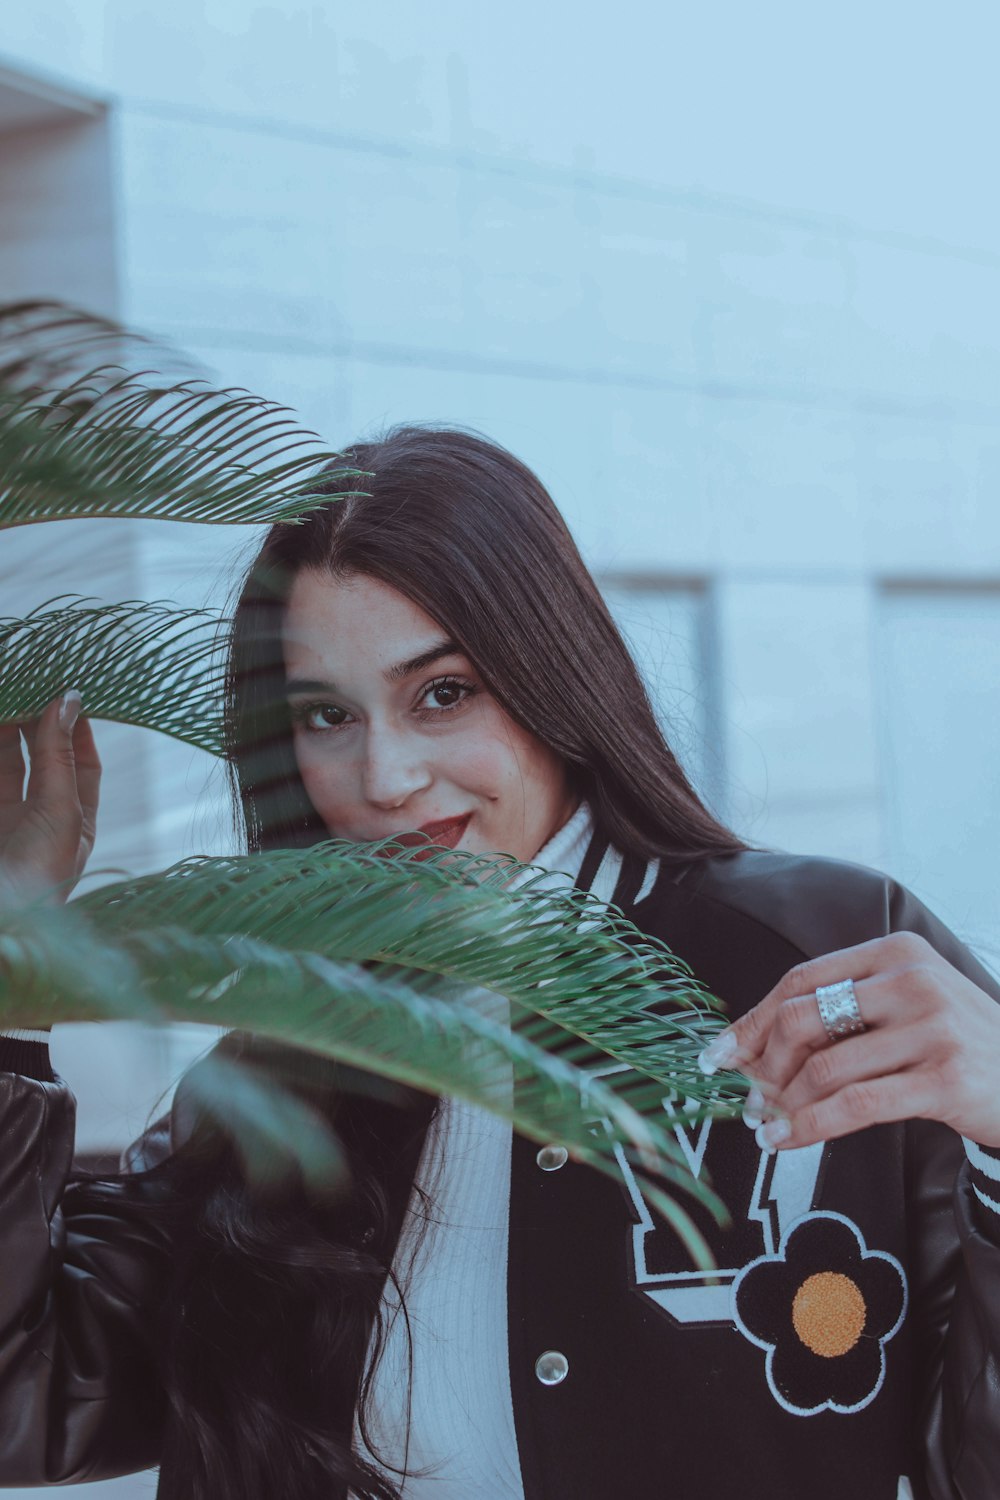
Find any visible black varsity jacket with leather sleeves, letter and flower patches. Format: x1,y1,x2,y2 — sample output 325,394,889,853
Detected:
0,836,1000,1500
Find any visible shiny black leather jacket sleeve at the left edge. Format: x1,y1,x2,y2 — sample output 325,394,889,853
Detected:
0,1046,168,1487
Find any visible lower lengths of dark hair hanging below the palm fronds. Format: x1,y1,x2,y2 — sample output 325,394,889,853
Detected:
150,1032,436,1500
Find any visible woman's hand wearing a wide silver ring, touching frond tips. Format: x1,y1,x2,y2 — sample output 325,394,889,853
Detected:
702,933,1000,1149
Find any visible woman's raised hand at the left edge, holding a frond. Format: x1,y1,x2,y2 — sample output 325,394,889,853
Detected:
0,690,100,902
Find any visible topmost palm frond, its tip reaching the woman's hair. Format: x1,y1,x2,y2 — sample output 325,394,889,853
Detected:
0,302,363,527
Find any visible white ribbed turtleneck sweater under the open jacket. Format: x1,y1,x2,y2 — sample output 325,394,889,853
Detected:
355,803,592,1500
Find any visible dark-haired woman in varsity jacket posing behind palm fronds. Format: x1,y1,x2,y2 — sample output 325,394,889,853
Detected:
0,428,1000,1500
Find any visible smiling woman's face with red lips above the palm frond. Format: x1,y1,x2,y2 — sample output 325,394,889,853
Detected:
283,569,576,860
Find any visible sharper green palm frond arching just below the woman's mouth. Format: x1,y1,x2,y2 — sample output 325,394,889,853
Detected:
73,840,734,1109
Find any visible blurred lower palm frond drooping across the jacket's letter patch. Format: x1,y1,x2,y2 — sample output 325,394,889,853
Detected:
0,888,734,1262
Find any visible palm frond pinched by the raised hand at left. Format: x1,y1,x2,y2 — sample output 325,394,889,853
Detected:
0,594,225,755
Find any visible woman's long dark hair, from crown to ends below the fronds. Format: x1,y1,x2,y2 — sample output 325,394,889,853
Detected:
146,426,744,1500
